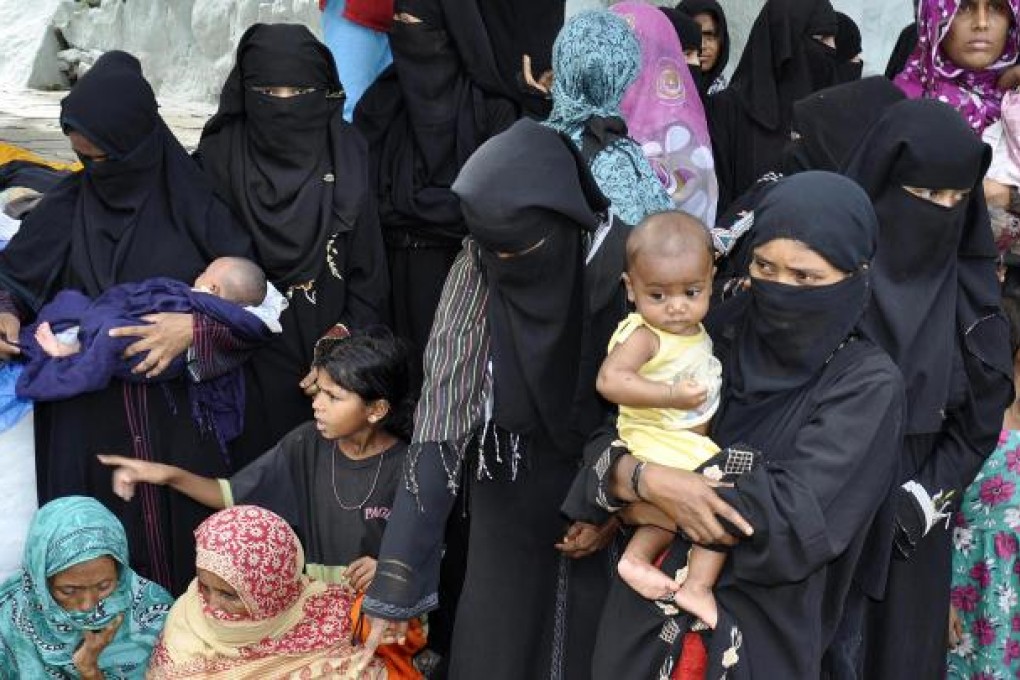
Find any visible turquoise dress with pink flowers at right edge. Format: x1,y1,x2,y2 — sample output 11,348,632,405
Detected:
948,430,1020,680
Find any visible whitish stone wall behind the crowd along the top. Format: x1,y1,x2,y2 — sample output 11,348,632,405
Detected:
0,0,911,104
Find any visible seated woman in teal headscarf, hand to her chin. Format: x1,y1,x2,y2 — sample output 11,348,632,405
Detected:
0,495,173,680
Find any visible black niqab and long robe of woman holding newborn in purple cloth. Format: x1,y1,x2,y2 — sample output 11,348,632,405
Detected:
0,51,252,592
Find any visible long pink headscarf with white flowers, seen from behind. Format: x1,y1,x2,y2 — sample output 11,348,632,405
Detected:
610,0,718,227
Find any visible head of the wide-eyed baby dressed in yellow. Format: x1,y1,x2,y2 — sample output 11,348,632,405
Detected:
623,211,715,335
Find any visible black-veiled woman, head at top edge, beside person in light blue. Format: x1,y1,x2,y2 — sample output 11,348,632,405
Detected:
354,0,517,383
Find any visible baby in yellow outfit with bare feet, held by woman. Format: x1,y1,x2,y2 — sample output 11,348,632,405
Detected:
598,212,725,626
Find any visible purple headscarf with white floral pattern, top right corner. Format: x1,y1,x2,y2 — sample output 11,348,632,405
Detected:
895,0,1020,135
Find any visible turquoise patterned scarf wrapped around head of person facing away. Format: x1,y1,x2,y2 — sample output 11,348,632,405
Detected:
547,10,641,135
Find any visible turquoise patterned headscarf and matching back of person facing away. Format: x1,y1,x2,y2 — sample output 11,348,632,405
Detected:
546,10,673,225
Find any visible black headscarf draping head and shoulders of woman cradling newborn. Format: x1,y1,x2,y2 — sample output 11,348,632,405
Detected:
0,51,251,310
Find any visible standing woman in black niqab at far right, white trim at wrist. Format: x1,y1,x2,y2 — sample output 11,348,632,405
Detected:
847,95,1013,678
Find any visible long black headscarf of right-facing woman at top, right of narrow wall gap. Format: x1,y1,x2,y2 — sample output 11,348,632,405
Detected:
729,0,839,130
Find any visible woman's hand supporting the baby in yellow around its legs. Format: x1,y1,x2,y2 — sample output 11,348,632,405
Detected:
642,464,754,545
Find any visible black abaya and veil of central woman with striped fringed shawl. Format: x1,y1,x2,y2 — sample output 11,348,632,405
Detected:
364,119,622,680
